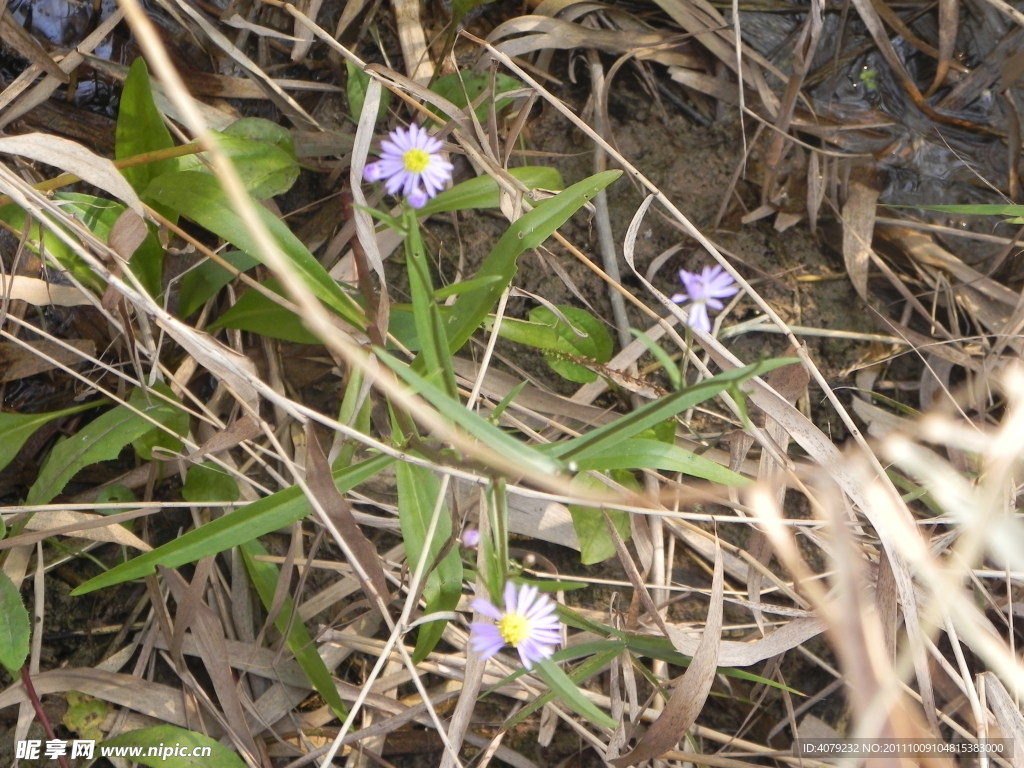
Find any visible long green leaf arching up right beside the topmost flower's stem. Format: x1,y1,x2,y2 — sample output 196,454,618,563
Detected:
438,171,622,354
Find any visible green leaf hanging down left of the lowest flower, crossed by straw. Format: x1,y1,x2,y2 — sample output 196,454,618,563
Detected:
395,454,462,662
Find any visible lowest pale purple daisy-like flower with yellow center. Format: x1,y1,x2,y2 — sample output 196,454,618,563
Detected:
469,582,562,670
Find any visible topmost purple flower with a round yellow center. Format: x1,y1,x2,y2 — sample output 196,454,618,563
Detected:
362,125,454,208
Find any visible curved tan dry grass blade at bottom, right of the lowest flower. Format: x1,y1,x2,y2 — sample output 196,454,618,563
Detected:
608,550,725,768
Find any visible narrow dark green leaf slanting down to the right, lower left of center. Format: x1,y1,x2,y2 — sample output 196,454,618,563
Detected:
239,541,348,720
